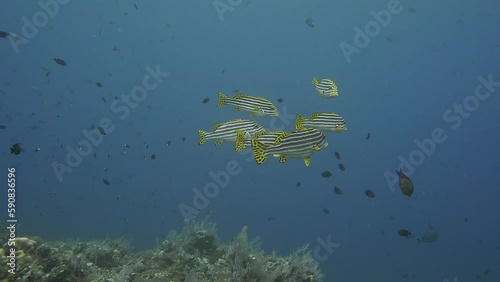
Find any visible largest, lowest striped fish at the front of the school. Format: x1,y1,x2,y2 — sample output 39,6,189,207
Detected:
252,128,328,166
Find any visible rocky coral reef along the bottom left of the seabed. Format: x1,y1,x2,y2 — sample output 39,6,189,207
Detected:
0,221,323,282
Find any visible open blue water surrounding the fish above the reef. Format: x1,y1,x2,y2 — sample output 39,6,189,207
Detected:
0,0,500,282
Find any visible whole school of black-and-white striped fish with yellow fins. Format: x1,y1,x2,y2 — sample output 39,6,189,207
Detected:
198,77,347,166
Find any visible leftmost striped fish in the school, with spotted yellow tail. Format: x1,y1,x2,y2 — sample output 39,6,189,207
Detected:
198,119,264,149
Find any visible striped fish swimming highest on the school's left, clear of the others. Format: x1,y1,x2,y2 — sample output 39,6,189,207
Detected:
217,92,278,117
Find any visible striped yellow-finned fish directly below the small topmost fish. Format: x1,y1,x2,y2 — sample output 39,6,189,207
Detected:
295,113,347,132
